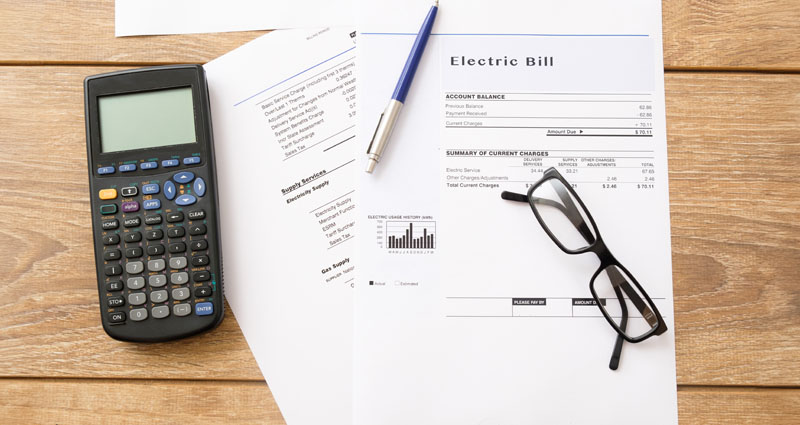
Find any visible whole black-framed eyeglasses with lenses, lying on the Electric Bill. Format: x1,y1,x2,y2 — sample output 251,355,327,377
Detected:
500,168,667,370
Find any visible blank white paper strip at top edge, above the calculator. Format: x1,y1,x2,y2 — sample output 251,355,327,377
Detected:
114,0,354,37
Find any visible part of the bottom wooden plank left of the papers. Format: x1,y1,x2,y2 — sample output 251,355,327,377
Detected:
0,379,285,425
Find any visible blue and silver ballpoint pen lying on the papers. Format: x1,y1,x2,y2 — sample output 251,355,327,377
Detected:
367,0,439,173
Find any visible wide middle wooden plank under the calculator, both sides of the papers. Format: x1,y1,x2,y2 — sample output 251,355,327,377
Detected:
0,67,800,386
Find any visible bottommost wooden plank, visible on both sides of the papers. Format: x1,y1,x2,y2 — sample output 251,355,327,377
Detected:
0,379,800,425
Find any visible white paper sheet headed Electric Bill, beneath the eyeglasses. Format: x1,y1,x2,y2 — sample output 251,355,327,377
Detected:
354,0,677,424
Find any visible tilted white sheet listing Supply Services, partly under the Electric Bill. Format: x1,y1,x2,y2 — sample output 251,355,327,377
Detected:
204,28,356,425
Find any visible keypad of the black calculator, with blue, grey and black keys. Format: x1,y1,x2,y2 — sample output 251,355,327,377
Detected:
96,165,218,325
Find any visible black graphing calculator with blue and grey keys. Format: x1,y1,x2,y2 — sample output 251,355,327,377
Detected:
84,65,223,342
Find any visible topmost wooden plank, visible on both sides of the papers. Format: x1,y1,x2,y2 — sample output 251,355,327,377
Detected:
0,0,800,70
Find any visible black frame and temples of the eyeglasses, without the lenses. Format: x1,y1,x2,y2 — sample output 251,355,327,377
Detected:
500,167,667,370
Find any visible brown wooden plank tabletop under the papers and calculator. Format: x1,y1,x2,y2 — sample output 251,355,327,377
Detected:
0,0,800,424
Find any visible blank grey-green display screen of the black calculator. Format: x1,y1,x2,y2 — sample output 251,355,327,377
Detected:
98,87,197,153
